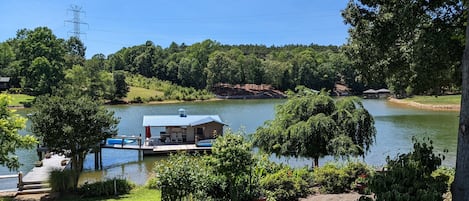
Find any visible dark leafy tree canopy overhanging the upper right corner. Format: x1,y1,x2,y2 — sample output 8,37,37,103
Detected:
342,0,464,95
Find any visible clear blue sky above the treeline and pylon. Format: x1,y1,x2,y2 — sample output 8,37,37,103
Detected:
0,0,348,58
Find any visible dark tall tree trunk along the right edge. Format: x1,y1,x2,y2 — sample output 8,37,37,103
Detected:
451,9,469,201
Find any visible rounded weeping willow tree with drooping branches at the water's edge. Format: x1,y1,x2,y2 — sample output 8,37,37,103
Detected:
253,87,376,167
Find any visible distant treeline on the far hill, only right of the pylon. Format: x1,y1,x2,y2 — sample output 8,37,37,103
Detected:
106,40,362,93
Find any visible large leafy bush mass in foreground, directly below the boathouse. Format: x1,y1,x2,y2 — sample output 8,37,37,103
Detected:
151,132,256,200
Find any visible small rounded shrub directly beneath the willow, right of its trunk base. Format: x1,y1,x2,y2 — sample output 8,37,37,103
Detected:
313,163,350,193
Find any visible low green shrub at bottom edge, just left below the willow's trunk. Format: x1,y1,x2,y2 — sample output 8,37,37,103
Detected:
259,167,313,201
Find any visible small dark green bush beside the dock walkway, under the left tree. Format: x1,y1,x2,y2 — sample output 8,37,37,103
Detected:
49,169,77,193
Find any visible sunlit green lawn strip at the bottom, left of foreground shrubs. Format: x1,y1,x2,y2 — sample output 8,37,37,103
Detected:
57,186,161,201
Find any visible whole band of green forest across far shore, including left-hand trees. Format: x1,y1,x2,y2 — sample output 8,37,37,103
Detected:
0,27,361,100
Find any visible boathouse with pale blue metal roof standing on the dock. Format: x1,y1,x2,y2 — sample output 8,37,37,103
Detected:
143,109,226,145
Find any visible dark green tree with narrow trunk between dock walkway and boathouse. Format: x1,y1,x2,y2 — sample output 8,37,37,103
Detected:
31,96,119,187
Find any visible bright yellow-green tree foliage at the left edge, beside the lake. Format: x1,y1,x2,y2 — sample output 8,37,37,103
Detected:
0,94,37,170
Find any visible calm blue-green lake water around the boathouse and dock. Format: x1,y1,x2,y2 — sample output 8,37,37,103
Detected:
0,100,459,189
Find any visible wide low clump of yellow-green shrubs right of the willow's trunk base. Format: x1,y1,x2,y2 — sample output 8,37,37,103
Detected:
313,161,374,193
